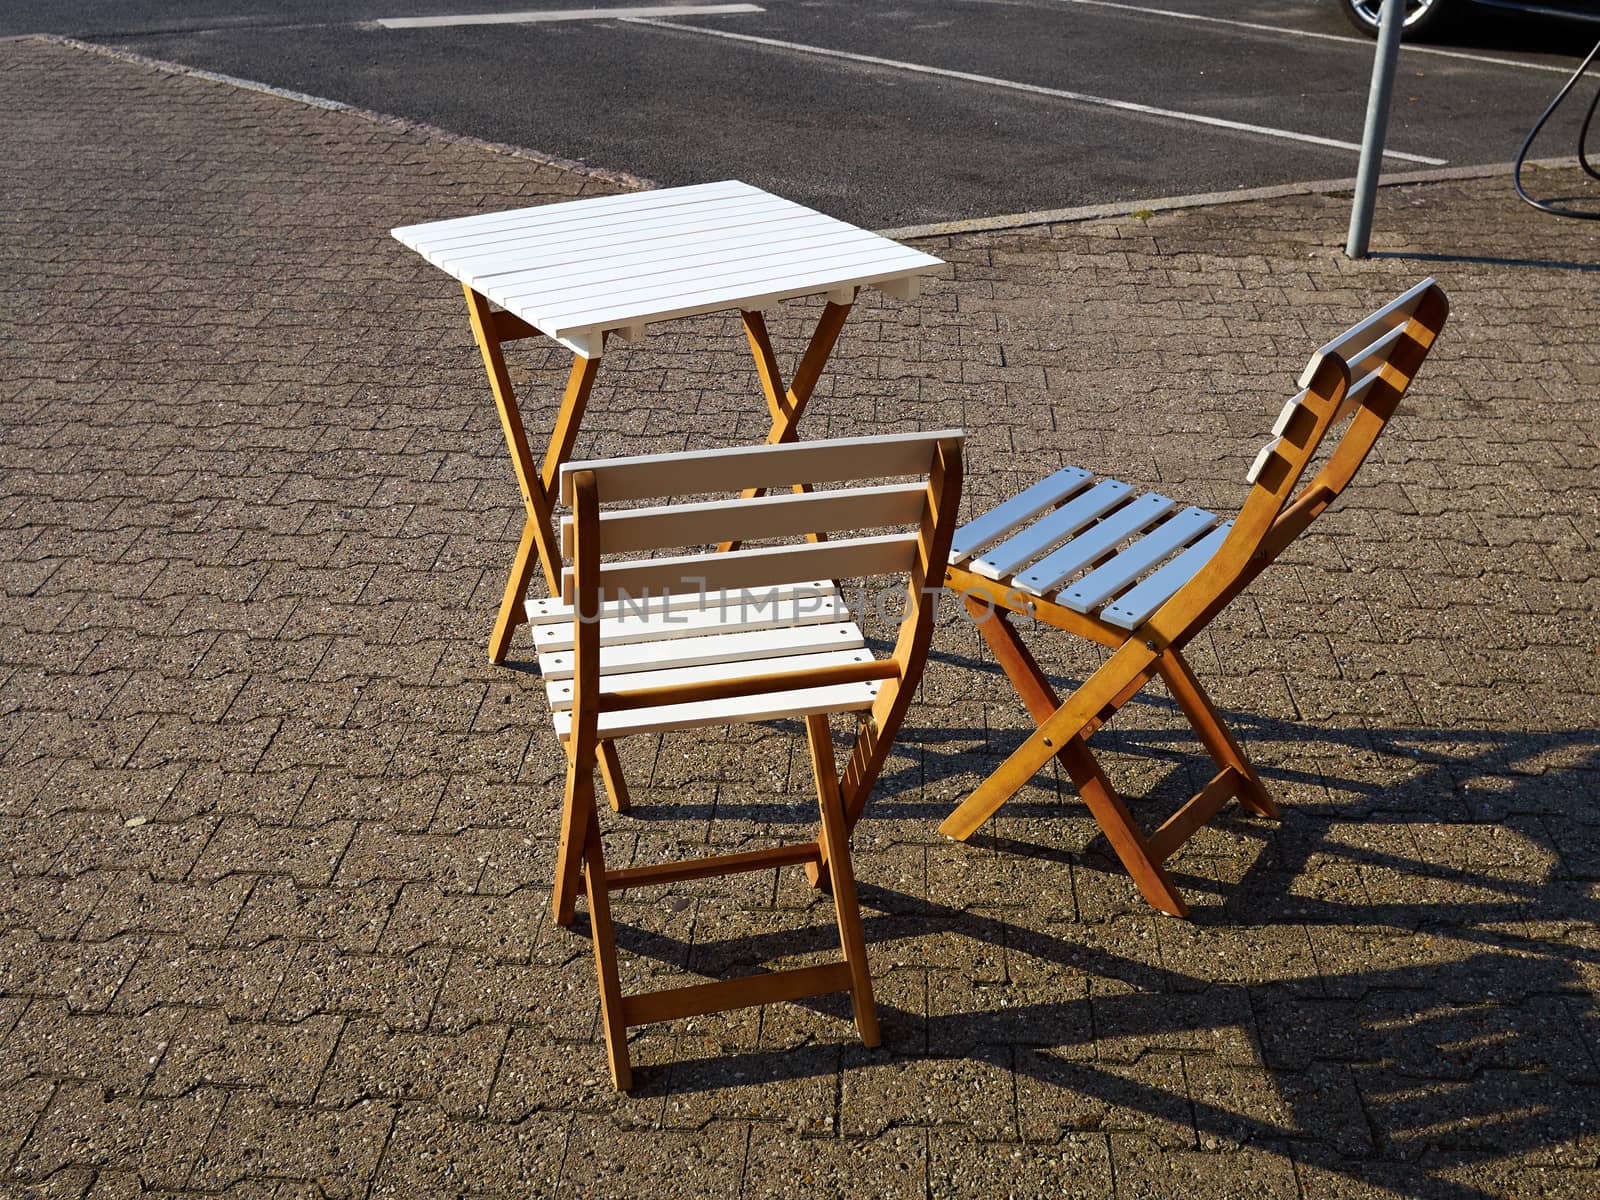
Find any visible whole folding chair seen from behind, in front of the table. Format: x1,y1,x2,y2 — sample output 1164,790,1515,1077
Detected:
530,432,962,1088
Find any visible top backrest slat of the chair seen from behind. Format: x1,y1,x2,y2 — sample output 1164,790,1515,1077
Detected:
562,429,962,506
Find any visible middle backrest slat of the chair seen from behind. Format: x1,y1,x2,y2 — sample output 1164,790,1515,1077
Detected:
562,483,928,557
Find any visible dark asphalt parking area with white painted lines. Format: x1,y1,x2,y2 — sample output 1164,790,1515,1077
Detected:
12,0,1600,229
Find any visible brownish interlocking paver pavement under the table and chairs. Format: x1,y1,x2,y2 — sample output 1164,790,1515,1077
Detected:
0,32,1600,1200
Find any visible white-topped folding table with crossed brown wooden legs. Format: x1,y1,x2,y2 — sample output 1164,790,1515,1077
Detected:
392,179,944,662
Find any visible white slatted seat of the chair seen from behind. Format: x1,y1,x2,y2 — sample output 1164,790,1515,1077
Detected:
528,579,883,741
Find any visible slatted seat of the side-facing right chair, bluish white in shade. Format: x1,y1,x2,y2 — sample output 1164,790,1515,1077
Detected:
950,467,1234,629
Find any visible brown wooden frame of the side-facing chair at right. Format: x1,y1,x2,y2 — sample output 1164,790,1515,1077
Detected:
939,280,1450,917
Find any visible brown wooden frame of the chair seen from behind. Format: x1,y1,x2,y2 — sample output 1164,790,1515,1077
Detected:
552,435,962,1090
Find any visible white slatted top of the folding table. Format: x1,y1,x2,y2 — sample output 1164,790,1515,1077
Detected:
392,179,944,358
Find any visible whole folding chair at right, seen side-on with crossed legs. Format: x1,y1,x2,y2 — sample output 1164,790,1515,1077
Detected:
939,278,1450,917
